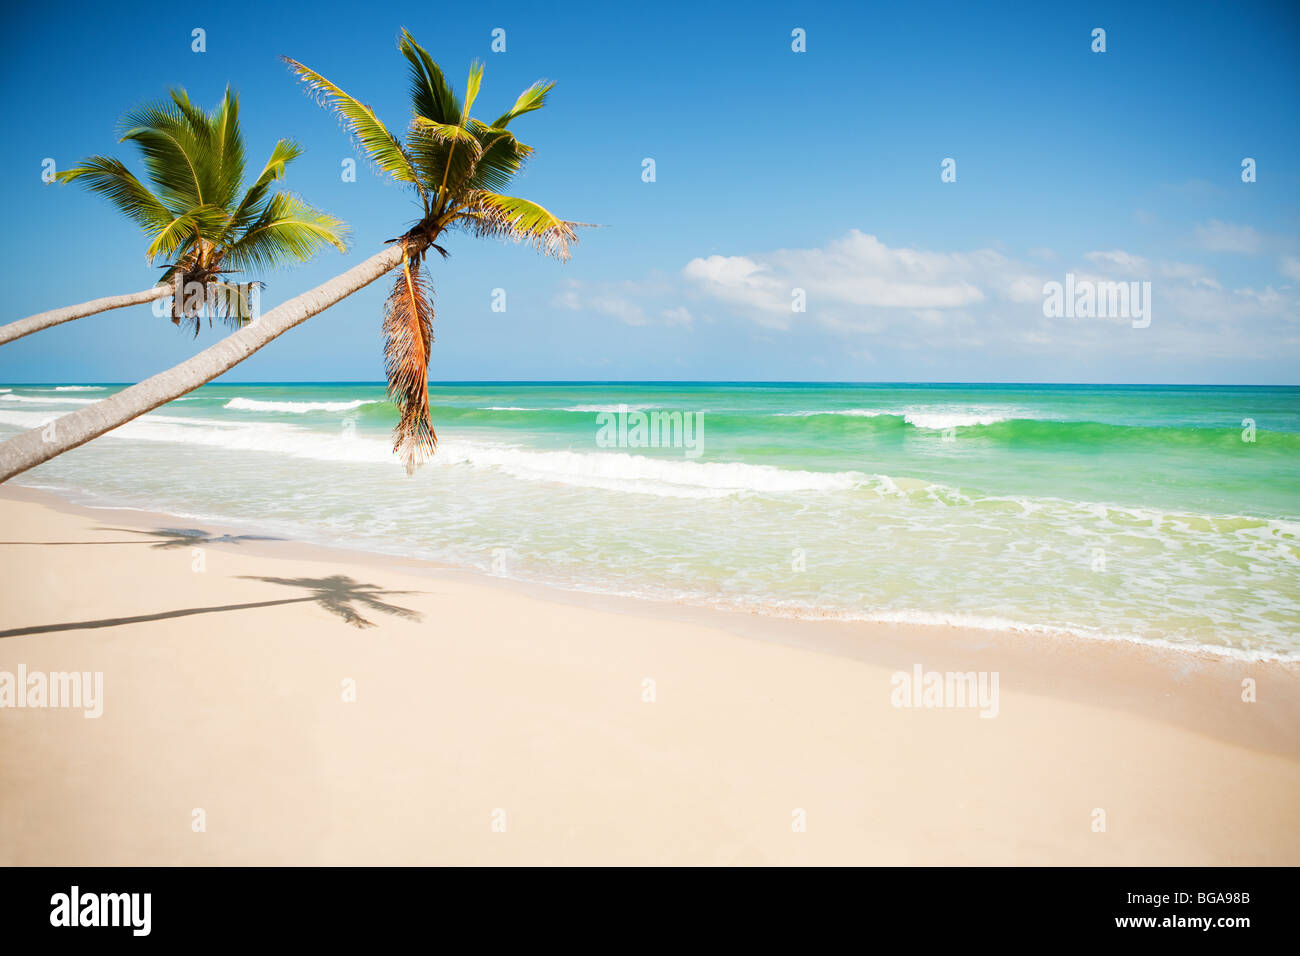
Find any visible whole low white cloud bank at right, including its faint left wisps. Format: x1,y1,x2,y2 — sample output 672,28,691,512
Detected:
555,222,1300,375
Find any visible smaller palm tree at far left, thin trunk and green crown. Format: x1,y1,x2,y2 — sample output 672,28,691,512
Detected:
0,87,347,345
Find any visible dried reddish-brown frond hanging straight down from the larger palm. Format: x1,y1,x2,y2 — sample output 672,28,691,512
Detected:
384,243,438,475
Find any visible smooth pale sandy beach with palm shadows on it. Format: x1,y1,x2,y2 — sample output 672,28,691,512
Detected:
0,488,1300,865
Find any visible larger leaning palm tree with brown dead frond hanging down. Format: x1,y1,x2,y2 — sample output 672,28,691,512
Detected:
0,30,579,481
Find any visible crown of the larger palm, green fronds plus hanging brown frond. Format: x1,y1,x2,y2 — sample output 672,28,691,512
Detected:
291,30,581,473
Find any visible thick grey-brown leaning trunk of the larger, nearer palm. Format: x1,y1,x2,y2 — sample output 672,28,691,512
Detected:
0,245,402,481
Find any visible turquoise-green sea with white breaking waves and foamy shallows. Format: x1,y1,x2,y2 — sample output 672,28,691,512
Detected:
0,382,1300,661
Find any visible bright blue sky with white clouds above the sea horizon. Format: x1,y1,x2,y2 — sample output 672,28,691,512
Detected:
0,3,1300,384
